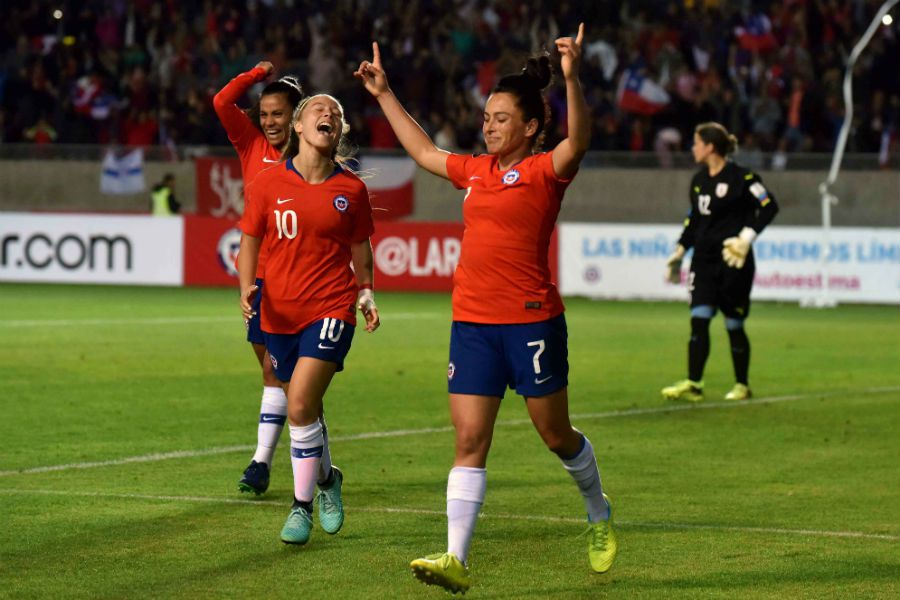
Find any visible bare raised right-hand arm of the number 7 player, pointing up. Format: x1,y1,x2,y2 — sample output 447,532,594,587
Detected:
553,23,591,179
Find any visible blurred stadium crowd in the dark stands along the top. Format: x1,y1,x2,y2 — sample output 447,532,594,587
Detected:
0,0,900,153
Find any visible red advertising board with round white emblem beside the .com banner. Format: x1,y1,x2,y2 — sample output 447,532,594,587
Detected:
183,215,241,286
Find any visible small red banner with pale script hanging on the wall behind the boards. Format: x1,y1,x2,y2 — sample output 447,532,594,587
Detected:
194,157,244,219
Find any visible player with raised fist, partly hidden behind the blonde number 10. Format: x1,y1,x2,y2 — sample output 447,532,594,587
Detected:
213,62,308,495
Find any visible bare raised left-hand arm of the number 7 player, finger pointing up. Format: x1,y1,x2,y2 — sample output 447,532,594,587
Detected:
353,42,450,179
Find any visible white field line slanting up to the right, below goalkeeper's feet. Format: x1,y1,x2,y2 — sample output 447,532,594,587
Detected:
0,386,900,477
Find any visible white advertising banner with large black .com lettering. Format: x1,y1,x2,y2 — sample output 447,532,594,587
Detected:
0,213,184,285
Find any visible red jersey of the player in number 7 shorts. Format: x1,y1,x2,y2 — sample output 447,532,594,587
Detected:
447,152,571,324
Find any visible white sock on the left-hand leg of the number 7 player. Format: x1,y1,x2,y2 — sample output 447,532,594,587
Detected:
447,467,487,563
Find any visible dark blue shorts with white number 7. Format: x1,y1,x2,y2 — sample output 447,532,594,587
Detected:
447,315,569,398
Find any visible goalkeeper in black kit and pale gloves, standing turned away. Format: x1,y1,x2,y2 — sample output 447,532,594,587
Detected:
662,123,778,402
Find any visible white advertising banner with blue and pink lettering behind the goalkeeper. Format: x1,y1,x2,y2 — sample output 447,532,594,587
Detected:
559,223,900,304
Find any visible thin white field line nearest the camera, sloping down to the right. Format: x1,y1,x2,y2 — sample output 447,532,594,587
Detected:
0,488,900,542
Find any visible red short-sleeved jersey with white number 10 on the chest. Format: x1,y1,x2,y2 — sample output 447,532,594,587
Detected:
241,161,374,333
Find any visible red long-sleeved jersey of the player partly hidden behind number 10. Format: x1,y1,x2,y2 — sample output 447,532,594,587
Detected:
213,67,281,279
